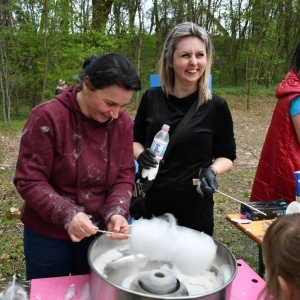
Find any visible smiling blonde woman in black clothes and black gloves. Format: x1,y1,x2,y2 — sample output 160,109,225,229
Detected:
134,22,236,235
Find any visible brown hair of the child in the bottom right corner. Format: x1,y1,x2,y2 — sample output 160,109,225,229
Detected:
259,213,300,299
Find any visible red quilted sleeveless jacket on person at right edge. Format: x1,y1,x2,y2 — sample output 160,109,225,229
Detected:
250,71,300,203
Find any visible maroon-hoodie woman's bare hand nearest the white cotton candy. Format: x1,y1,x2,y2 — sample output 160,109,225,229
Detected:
107,215,130,240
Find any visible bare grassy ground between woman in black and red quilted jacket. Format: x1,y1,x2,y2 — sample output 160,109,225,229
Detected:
214,97,277,272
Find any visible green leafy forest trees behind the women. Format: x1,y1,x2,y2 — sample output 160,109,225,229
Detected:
0,0,300,126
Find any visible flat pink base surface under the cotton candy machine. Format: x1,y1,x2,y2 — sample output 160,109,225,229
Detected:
30,260,265,300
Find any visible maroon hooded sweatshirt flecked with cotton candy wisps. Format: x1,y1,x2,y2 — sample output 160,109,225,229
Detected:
14,86,135,240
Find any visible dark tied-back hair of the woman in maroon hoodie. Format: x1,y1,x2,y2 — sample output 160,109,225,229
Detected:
75,53,142,91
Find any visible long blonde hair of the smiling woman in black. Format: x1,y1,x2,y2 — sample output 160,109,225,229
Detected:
158,22,213,106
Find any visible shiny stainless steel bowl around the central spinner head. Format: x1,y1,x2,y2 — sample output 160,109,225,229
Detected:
88,229,237,300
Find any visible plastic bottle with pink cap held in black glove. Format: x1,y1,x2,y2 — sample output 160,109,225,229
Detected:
142,124,170,181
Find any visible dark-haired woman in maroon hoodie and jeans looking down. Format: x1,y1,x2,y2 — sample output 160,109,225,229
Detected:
14,53,141,280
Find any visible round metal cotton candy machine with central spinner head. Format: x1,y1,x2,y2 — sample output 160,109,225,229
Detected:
88,229,237,300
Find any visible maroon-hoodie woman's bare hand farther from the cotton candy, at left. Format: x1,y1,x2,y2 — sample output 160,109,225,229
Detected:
68,212,99,242
